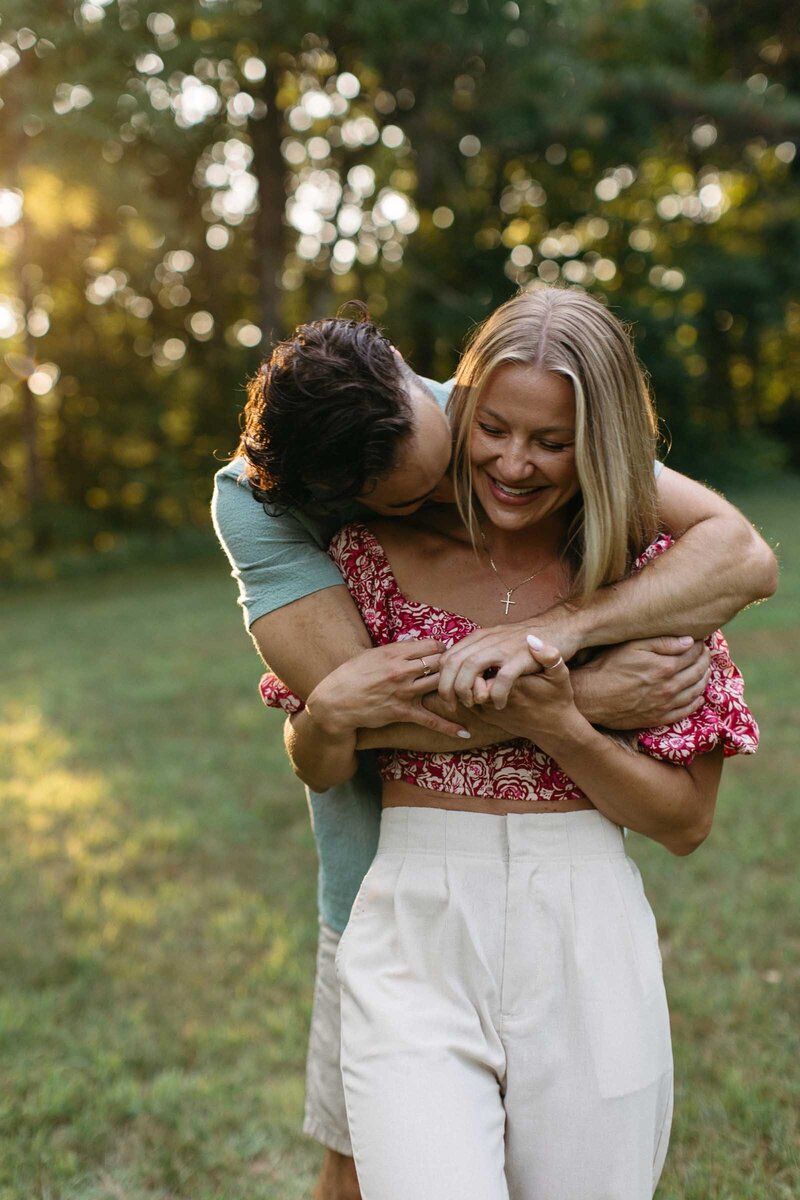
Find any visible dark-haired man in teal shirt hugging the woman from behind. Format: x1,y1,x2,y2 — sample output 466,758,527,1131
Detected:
213,319,775,1200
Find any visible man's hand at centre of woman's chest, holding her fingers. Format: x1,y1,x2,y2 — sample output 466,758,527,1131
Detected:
439,618,579,710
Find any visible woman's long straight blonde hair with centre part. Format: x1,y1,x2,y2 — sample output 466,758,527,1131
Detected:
447,287,657,600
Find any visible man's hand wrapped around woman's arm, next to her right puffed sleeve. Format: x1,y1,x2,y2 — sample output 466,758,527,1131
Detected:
572,637,710,730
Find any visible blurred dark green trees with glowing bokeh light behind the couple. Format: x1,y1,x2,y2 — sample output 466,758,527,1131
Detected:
0,0,800,574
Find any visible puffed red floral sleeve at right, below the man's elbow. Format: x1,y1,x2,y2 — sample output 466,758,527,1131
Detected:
637,630,759,766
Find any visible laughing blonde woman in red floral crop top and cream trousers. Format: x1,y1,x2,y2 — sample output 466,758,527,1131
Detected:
264,289,757,1200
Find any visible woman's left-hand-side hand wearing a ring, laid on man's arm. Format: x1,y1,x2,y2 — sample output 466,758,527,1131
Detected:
306,638,469,738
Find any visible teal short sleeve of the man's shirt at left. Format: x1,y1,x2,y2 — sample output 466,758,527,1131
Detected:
211,468,342,628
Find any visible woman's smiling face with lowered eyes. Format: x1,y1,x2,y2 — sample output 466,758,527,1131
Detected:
470,362,579,532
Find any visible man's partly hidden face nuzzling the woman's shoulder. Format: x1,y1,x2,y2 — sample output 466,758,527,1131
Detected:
359,384,452,517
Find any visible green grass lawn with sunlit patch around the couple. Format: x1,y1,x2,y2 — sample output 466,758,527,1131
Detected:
0,485,800,1200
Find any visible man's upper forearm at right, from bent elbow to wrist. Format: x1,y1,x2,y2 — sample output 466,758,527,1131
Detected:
544,517,775,653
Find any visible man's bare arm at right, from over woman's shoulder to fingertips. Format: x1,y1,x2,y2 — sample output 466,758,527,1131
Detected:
439,468,777,708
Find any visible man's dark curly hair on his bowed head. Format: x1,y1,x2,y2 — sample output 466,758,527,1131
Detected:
237,310,415,509
